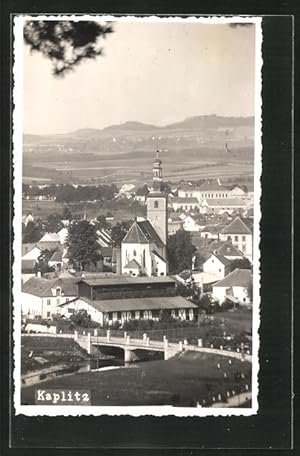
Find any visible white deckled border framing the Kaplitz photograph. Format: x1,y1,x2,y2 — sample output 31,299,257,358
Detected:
13,15,263,417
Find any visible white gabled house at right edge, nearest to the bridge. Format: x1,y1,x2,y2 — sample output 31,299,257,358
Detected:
212,268,253,304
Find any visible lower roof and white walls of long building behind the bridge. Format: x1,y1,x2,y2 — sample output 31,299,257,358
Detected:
59,296,197,326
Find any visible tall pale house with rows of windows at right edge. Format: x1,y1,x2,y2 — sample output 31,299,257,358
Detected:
219,217,253,262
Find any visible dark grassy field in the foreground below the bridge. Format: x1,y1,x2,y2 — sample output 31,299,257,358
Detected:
22,352,251,407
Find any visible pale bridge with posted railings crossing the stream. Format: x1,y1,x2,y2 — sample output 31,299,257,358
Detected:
74,330,252,363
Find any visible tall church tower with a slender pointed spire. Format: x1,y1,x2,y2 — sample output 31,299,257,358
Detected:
147,151,168,246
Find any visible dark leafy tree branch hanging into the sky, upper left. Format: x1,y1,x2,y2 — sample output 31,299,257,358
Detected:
24,21,113,76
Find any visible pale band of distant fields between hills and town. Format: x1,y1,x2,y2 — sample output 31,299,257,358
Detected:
23,143,254,185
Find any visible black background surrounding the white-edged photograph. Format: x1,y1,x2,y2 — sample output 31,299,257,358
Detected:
0,0,299,454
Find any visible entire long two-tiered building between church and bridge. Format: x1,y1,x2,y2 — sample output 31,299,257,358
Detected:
60,275,197,326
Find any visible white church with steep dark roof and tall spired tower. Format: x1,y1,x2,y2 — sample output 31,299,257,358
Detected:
121,152,168,277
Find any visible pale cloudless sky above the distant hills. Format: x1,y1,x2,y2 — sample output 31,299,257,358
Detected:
23,22,255,134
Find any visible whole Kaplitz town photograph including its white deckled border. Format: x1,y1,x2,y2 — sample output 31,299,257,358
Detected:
13,14,263,417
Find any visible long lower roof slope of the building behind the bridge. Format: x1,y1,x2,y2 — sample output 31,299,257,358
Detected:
69,296,197,312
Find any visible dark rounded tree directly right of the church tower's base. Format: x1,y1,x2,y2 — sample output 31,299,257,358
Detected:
168,230,196,273
